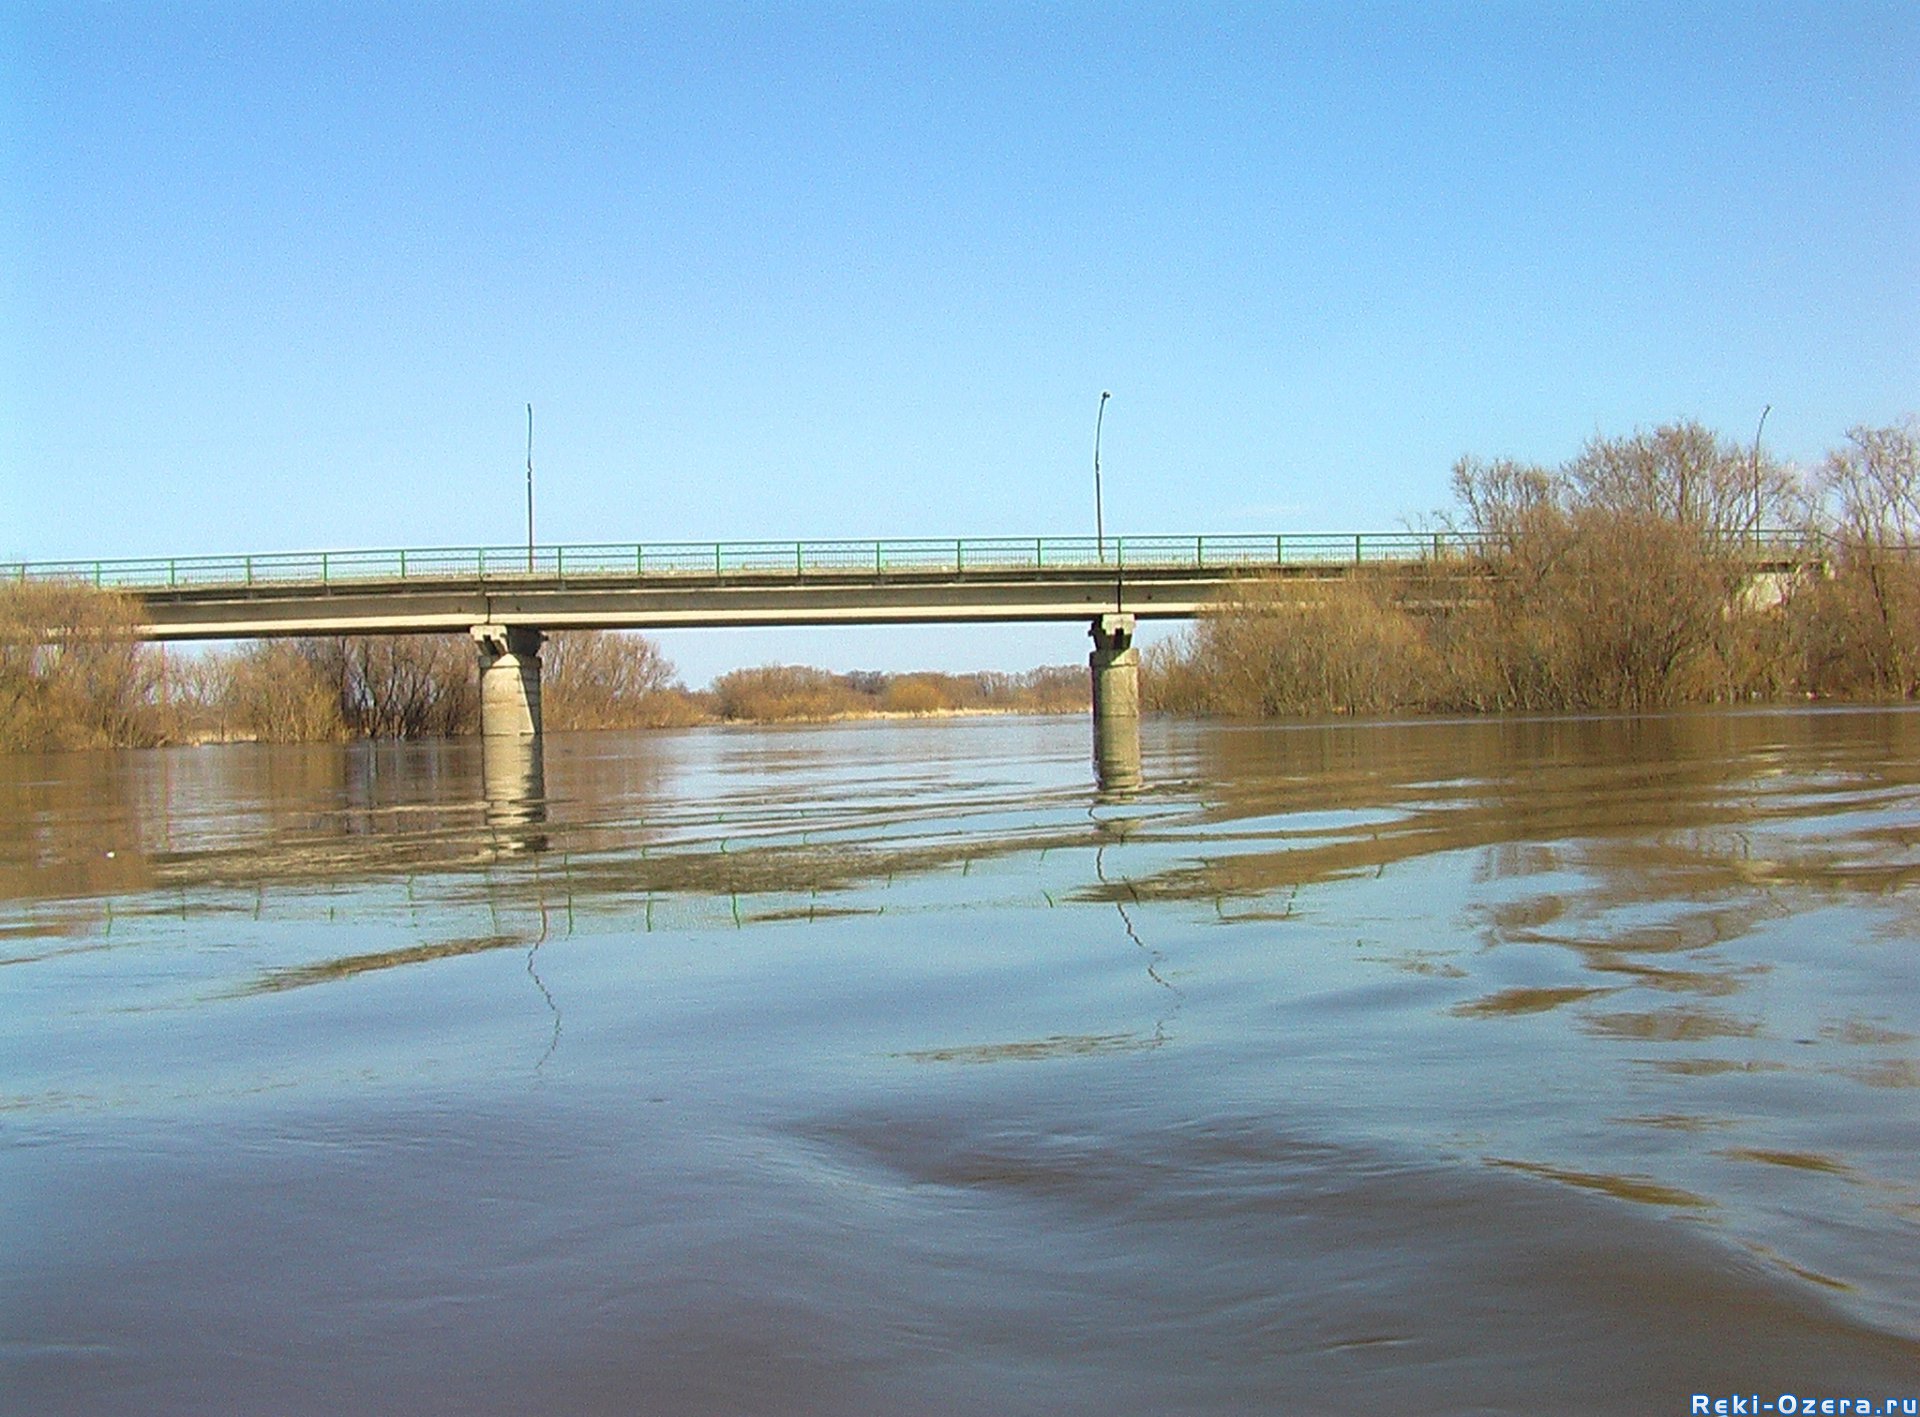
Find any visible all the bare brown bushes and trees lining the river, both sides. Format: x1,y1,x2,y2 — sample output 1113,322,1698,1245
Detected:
11,419,1920,751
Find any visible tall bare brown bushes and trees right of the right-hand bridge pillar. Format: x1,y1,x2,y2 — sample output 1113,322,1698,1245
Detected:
1142,419,1920,716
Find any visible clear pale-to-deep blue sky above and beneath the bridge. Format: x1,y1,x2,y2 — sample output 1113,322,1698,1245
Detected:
0,0,1920,682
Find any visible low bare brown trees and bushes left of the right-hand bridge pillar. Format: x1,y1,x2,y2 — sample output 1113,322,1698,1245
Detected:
0,582,1087,753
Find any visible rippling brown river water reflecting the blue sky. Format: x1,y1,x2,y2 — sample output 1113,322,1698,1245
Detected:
0,710,1920,1413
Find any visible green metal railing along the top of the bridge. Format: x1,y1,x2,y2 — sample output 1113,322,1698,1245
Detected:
0,532,1811,591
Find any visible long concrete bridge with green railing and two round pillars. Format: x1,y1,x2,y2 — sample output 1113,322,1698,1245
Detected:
0,532,1807,780
